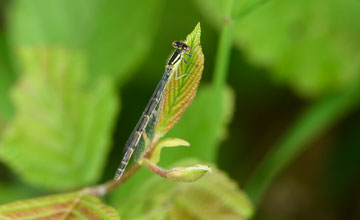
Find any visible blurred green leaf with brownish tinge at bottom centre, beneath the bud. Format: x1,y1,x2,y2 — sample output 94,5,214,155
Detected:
115,161,253,219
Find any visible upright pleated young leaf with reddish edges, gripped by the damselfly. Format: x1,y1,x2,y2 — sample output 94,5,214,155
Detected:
156,23,204,136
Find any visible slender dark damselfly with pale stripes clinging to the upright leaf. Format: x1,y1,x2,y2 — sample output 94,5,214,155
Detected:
114,41,195,180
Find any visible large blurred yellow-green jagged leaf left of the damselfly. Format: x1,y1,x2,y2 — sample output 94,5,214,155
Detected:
0,47,118,189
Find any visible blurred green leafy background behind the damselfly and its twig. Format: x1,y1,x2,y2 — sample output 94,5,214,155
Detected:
0,0,360,219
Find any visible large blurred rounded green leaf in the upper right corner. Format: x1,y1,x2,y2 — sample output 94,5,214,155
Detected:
234,0,360,96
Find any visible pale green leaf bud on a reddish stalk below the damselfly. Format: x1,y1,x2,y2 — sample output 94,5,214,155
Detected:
166,164,211,182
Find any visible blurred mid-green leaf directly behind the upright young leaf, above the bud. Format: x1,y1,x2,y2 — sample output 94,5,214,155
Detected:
161,86,235,165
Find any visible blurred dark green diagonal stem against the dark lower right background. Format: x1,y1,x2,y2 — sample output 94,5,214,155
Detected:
245,83,360,205
